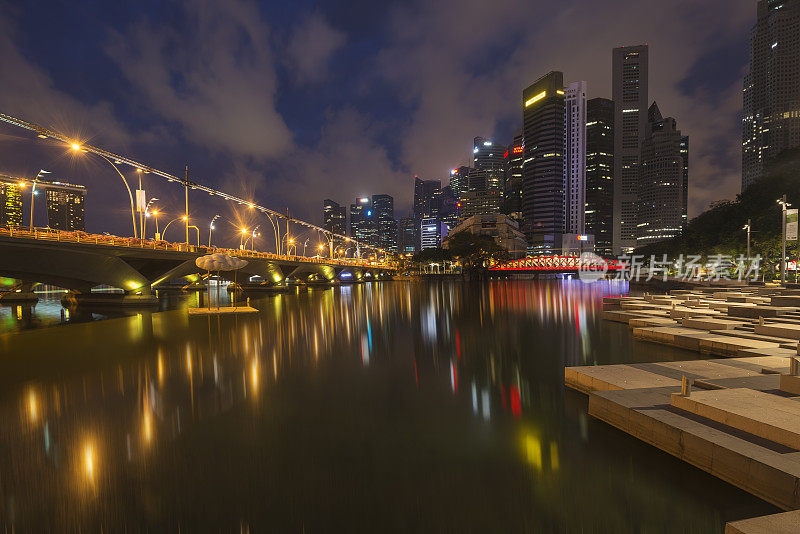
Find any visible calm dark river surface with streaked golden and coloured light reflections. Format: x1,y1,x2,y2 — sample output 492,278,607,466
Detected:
0,281,776,532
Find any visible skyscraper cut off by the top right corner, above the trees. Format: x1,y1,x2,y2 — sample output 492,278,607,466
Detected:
742,0,800,190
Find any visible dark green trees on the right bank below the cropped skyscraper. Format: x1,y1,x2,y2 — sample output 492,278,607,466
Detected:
636,149,800,270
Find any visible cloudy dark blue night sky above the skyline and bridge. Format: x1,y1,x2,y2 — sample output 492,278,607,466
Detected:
0,0,756,247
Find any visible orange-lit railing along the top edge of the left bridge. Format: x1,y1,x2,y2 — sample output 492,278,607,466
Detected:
0,227,392,268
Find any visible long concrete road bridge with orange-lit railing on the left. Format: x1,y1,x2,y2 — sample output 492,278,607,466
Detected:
0,228,395,302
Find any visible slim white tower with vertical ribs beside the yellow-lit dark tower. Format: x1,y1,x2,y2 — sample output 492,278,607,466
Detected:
564,82,586,234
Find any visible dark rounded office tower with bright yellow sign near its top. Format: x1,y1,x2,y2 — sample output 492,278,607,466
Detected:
522,71,564,253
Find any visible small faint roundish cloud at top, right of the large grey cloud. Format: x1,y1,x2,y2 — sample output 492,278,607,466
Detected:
286,12,347,85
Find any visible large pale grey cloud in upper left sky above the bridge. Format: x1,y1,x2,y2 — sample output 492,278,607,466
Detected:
107,0,292,159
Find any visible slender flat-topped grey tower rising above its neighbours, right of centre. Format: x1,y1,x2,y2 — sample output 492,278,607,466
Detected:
611,45,648,254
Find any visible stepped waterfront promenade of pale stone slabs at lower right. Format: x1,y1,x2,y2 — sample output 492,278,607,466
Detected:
564,287,800,532
